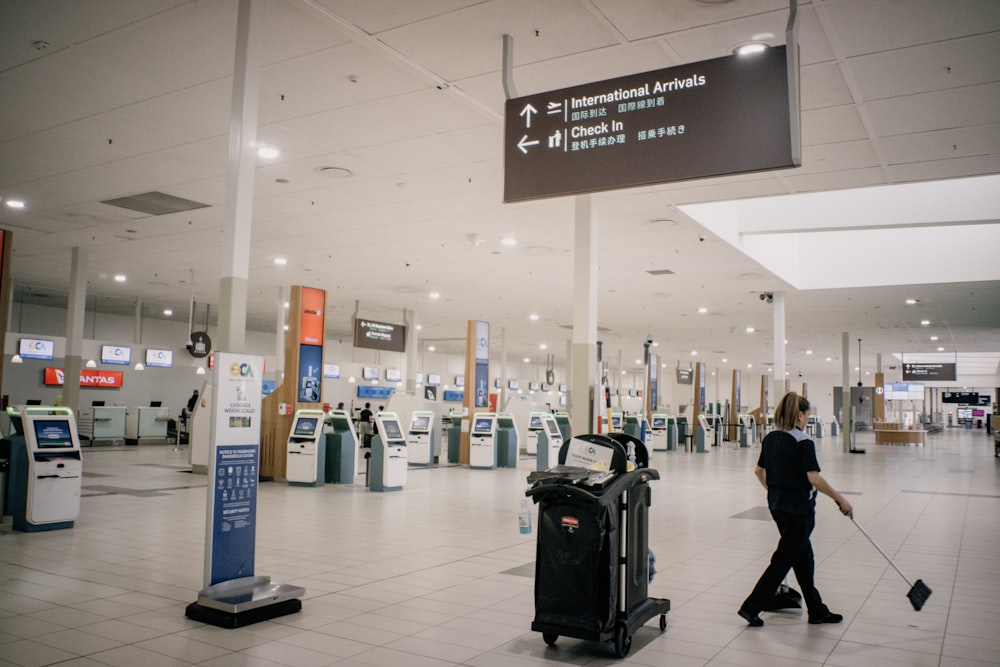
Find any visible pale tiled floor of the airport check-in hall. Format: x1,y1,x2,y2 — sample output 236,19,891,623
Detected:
0,430,1000,667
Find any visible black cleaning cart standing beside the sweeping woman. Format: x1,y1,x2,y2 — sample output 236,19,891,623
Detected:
526,434,670,658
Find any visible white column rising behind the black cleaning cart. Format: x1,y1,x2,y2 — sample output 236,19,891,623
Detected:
567,195,597,433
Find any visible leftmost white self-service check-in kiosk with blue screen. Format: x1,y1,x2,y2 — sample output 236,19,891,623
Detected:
11,407,83,533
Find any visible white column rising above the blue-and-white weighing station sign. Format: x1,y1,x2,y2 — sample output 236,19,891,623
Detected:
218,0,262,352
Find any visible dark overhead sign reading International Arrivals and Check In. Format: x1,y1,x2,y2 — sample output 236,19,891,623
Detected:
504,46,799,202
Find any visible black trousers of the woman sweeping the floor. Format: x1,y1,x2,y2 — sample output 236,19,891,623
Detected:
741,510,830,617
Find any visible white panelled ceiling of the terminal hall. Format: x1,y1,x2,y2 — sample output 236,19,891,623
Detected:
0,0,1000,379
